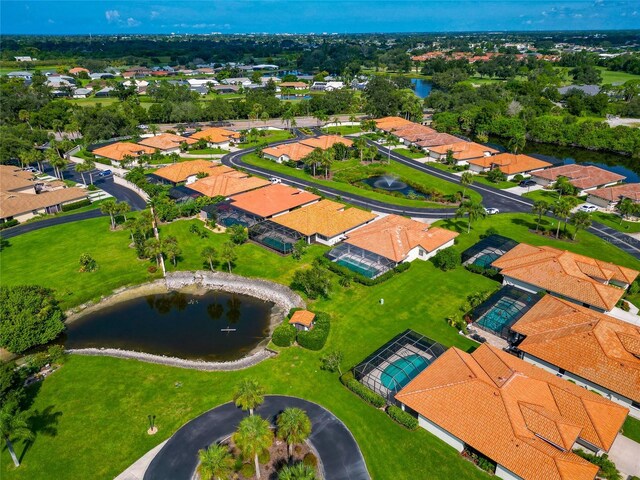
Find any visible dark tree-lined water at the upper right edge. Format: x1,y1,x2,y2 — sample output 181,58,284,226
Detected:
489,139,640,183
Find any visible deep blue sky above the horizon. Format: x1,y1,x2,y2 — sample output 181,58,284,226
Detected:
0,0,640,34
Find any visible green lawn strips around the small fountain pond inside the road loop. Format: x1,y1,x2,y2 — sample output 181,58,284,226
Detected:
242,154,481,208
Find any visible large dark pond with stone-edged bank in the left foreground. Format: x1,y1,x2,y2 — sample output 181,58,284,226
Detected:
63,291,273,361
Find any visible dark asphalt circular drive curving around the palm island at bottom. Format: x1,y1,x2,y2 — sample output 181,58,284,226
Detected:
144,395,371,480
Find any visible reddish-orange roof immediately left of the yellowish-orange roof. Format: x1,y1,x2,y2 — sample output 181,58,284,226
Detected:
231,183,320,217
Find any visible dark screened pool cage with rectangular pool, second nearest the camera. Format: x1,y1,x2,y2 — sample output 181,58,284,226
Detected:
471,285,540,342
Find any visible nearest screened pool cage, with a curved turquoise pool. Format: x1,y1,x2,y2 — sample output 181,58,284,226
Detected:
353,330,446,404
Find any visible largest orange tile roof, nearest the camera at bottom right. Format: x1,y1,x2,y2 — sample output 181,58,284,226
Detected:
396,344,628,480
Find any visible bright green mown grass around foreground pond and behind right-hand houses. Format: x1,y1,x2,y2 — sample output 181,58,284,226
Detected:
0,214,640,480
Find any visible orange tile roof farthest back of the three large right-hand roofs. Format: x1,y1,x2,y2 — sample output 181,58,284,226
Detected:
491,243,639,310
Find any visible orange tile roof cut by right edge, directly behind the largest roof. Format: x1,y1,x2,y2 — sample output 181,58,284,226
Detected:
511,295,640,402
